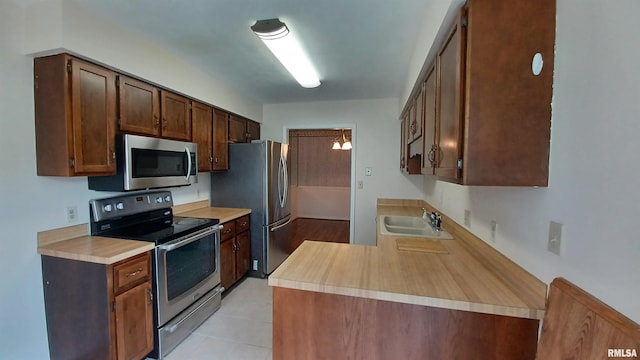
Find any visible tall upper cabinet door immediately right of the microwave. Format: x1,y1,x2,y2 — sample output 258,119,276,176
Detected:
191,101,213,172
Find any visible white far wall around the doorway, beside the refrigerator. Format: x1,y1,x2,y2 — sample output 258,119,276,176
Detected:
262,99,422,245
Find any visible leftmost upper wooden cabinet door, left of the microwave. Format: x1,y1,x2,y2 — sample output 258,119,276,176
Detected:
69,58,116,175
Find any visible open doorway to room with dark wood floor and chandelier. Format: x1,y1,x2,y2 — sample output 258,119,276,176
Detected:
287,128,353,243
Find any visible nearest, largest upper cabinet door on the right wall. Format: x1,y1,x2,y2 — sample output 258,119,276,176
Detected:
435,14,464,181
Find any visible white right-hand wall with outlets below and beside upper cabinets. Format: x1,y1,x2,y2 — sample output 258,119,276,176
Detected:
410,0,640,322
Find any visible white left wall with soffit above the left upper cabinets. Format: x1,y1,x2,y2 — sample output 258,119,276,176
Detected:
0,0,262,359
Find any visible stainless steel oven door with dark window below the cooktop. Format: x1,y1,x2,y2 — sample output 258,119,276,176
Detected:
156,225,222,327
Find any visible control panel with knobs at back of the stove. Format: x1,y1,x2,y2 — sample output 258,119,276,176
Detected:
89,191,173,221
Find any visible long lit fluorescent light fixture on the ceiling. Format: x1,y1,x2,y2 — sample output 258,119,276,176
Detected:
251,19,320,88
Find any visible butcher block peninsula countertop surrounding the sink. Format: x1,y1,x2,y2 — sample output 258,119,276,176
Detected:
269,199,546,320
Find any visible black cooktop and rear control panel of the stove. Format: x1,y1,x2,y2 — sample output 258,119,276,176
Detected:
90,191,220,245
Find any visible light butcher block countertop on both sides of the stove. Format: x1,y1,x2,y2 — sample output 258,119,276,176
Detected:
38,200,251,264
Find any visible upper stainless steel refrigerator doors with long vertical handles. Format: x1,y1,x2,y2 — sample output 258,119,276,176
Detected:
266,141,291,224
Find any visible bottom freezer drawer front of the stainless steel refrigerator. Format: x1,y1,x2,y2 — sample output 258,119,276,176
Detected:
265,216,296,274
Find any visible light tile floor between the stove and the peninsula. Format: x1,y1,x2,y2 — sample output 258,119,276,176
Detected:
165,278,273,360
